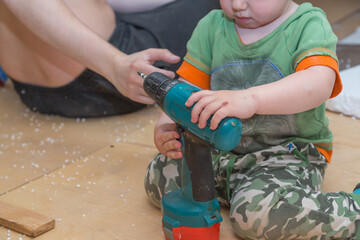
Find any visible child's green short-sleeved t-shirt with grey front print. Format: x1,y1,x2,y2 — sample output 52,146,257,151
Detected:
185,3,337,154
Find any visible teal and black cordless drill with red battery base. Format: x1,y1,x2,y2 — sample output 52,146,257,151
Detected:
139,72,242,240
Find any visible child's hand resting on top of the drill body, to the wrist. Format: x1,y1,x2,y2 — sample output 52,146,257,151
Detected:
185,90,256,130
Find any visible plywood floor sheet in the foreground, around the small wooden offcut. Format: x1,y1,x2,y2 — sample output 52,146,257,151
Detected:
0,143,238,240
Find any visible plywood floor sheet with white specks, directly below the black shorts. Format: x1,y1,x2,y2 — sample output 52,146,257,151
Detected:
0,82,159,195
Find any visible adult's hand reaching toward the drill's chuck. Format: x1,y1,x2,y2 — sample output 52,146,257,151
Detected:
112,48,180,104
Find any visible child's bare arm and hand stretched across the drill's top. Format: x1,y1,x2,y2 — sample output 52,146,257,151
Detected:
185,66,339,130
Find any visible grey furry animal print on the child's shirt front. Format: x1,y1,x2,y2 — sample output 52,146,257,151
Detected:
211,60,297,154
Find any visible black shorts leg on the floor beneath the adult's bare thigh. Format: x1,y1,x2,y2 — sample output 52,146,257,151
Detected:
12,69,146,118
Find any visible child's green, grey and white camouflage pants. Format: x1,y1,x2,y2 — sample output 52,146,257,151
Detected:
145,143,360,240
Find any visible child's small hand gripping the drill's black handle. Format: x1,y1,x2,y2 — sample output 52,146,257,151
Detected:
154,114,182,159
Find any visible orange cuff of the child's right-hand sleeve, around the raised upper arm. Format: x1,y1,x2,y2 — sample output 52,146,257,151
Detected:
295,55,342,98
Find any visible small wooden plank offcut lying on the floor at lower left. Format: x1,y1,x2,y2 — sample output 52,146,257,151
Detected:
0,201,55,237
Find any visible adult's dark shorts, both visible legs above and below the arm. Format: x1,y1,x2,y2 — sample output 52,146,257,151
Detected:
12,0,219,117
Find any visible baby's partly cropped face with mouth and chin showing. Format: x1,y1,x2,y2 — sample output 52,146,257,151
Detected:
220,0,292,29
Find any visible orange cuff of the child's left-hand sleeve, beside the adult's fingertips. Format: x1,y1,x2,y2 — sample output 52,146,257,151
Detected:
176,61,210,89
